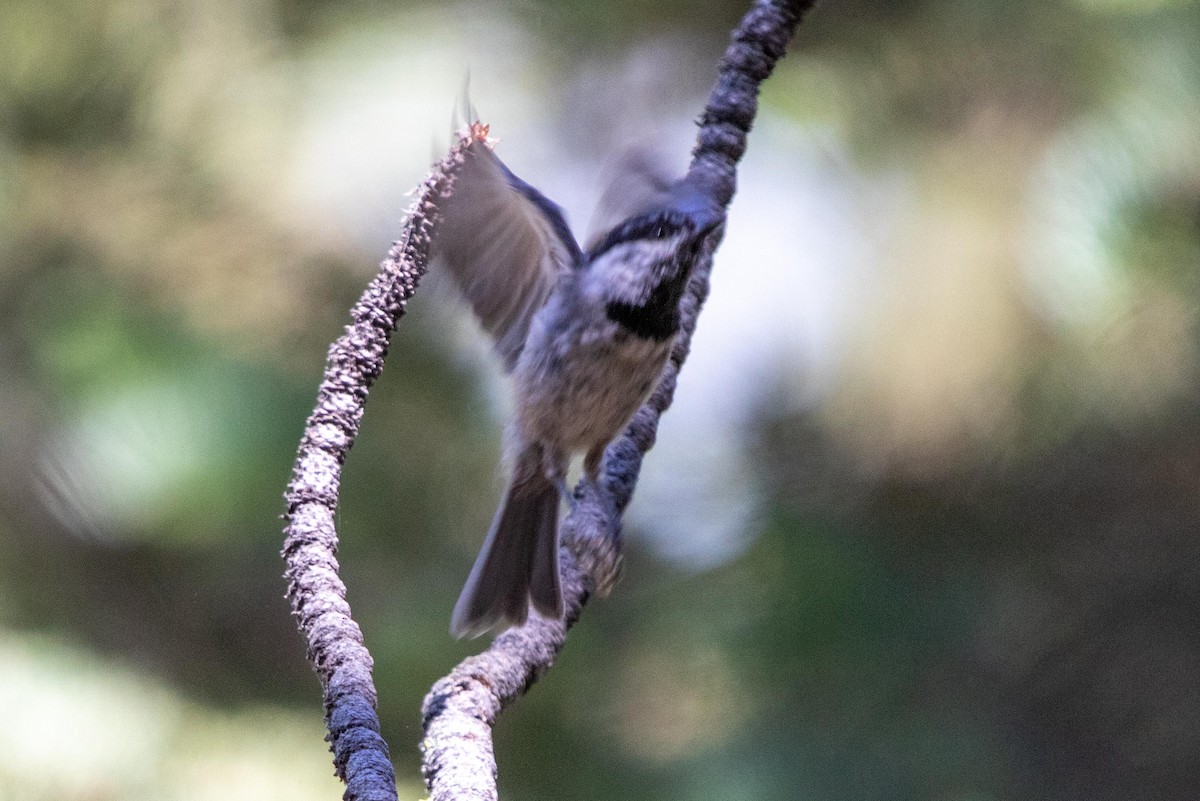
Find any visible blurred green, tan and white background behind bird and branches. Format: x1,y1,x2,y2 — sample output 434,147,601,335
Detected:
0,0,1200,801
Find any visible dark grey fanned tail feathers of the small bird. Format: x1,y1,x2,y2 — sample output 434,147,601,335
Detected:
450,448,563,637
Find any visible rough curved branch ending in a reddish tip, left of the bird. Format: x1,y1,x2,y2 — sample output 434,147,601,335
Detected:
283,131,482,801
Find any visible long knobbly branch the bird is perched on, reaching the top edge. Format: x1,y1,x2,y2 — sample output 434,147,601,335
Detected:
421,0,814,801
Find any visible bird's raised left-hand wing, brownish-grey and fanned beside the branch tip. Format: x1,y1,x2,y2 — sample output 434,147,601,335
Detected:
433,140,582,371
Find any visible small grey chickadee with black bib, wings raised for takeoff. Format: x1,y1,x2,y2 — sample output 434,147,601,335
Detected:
433,122,724,637
